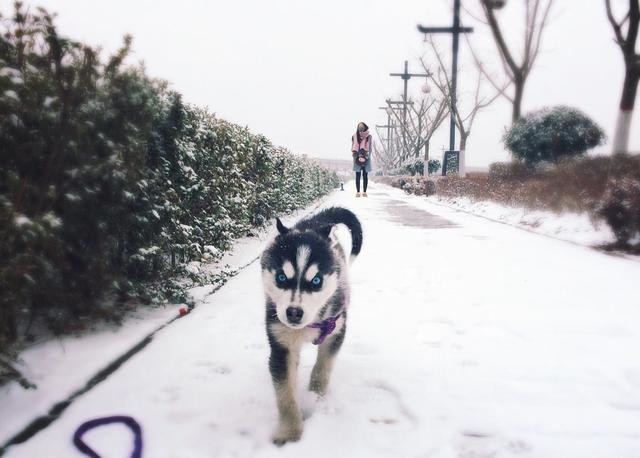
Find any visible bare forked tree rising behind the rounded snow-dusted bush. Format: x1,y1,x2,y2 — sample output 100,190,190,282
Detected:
476,0,556,122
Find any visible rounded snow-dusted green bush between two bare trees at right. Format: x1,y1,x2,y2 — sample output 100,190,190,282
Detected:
503,106,605,164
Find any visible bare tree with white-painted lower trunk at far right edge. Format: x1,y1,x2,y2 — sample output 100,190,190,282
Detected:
605,0,640,154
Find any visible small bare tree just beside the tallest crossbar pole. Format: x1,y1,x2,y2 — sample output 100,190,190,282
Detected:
422,38,509,177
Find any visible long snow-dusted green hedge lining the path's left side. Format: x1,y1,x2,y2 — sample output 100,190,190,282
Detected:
0,3,338,349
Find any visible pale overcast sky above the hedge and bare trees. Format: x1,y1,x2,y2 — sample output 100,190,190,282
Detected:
33,0,640,166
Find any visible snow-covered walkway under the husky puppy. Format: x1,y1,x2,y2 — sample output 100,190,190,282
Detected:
7,184,640,458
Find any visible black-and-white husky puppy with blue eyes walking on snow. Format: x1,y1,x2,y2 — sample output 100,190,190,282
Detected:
261,207,362,445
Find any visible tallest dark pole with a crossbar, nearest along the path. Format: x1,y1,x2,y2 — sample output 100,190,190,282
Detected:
418,0,473,175
